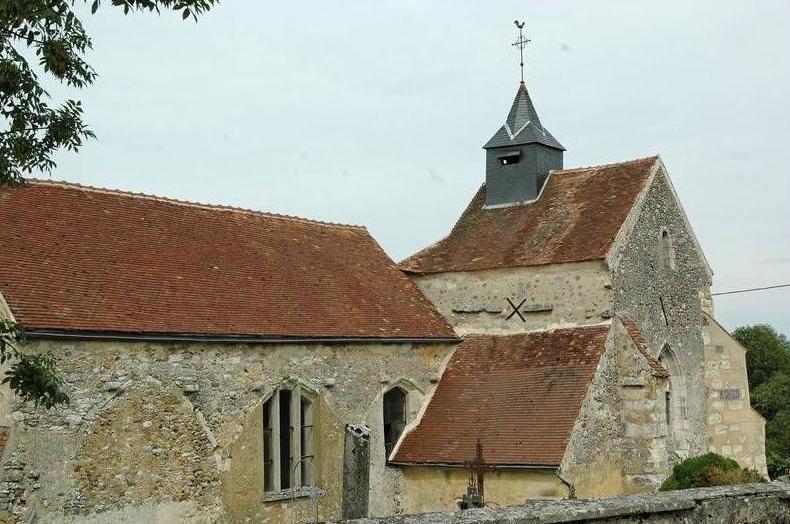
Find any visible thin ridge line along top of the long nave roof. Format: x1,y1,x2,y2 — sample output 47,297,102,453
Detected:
24,178,367,231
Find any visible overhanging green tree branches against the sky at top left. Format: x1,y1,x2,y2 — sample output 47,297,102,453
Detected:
0,0,218,185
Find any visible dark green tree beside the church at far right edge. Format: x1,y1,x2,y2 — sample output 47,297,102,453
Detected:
733,324,790,478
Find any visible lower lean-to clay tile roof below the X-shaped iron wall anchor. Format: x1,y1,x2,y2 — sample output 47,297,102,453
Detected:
393,325,609,466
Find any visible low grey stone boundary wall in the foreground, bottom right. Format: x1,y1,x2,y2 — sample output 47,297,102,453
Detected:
346,482,790,524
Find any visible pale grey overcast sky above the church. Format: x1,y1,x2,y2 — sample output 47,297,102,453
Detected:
46,0,790,334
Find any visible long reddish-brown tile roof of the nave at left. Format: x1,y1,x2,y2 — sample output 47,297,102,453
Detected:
0,181,454,339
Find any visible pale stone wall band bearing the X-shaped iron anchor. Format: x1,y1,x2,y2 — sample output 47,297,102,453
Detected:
412,262,612,334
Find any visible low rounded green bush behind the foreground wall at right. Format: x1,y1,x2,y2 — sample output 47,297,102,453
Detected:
661,453,765,491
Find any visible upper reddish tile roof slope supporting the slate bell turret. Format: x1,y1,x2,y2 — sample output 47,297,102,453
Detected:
400,156,660,273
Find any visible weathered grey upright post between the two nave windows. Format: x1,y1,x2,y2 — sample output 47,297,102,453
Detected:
343,424,370,519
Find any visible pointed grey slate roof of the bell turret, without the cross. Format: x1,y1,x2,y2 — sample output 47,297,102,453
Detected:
483,82,565,151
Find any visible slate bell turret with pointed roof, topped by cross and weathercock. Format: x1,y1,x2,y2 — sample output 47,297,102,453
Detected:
483,22,565,206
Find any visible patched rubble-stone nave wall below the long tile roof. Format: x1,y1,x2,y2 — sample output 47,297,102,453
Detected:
0,340,452,522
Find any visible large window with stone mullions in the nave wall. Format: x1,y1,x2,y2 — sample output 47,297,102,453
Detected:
263,384,315,491
